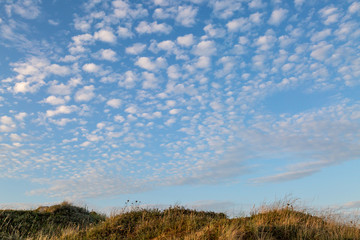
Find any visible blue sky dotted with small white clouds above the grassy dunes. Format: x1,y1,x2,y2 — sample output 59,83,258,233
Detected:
0,0,360,214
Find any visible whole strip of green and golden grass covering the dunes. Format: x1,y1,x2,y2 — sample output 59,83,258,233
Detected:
0,203,360,240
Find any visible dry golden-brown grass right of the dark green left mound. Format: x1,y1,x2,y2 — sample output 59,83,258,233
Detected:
0,202,360,240
